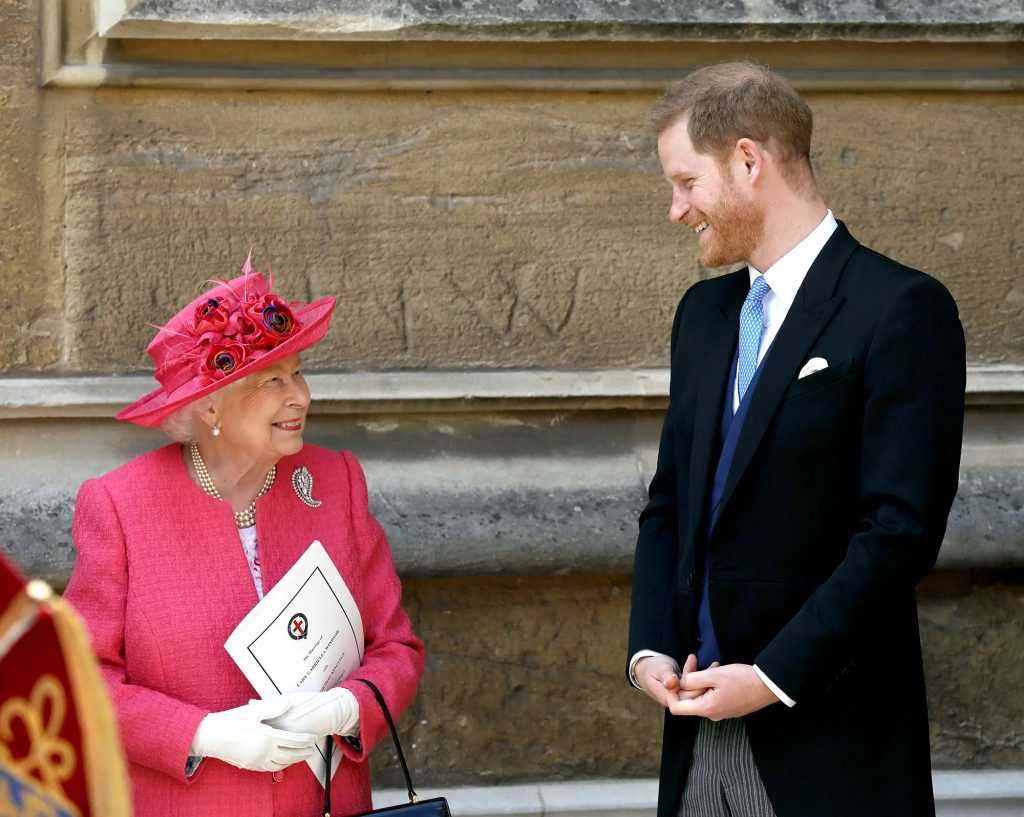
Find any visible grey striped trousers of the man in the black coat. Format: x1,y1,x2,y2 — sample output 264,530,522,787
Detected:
679,718,775,817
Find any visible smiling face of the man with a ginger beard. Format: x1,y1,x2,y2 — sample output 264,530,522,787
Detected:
657,119,765,267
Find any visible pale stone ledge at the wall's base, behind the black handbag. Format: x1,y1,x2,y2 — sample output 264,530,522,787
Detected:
374,770,1024,817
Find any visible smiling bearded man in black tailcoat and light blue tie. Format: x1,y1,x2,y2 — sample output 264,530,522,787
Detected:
629,62,966,817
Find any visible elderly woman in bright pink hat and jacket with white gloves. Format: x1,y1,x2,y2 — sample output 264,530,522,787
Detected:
66,252,424,817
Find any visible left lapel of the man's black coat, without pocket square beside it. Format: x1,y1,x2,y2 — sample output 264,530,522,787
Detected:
689,267,751,542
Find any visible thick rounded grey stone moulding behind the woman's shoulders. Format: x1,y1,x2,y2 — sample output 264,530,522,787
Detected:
0,421,1024,587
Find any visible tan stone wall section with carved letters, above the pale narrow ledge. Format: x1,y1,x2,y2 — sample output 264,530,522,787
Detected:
8,90,1024,374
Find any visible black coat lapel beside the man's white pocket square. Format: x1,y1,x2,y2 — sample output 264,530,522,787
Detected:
720,222,859,528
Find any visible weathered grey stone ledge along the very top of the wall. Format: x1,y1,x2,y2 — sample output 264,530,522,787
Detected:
97,0,1024,40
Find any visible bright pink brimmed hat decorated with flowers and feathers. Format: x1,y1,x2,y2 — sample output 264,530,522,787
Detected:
118,251,335,428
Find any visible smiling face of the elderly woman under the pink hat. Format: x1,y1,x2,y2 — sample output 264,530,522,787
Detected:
214,354,309,464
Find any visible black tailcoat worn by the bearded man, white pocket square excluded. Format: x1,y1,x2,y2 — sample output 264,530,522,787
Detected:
629,223,966,817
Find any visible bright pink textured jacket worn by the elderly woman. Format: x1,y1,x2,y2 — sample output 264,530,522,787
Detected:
65,445,424,817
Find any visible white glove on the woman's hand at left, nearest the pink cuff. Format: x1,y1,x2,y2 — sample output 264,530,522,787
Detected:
189,697,316,772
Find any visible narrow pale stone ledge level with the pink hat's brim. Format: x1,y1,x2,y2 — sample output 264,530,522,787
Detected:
0,366,1024,420
